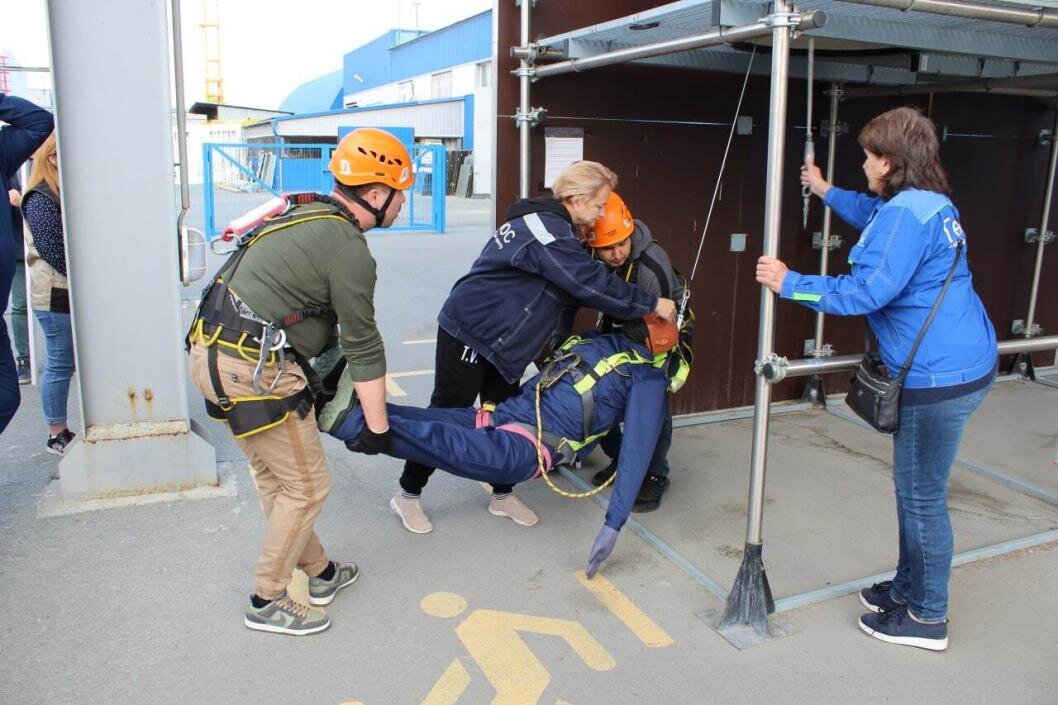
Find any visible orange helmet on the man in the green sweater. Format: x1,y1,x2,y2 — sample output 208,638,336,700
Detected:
330,127,415,191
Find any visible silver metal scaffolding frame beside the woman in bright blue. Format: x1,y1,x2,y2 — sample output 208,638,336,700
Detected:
511,0,1058,647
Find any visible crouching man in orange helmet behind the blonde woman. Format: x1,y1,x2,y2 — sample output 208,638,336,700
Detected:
554,192,693,511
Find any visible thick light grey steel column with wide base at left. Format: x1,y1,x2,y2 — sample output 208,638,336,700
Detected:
48,0,217,499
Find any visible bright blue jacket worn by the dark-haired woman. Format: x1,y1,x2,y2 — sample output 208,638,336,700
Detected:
782,186,997,388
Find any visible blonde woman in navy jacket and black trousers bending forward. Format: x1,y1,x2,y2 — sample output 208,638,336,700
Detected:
389,161,676,534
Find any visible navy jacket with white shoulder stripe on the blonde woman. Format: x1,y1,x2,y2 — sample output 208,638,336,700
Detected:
437,198,657,382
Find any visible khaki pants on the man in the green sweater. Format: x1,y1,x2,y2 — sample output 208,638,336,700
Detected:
188,344,330,599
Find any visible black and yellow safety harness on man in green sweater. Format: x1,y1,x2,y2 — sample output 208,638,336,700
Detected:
184,194,359,438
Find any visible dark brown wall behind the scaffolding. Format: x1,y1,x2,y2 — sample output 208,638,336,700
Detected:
495,0,1058,413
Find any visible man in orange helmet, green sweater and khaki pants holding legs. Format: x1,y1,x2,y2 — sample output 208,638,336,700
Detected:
187,128,414,635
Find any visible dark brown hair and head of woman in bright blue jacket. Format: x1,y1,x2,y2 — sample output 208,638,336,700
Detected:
859,108,951,198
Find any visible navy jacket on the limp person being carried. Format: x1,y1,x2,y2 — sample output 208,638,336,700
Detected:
492,333,669,530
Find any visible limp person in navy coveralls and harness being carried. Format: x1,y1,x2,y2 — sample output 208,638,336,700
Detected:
331,313,677,577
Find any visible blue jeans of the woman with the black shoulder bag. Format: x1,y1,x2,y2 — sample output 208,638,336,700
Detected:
891,384,991,622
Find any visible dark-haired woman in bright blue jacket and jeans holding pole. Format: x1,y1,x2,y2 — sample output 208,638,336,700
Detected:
756,108,997,651
